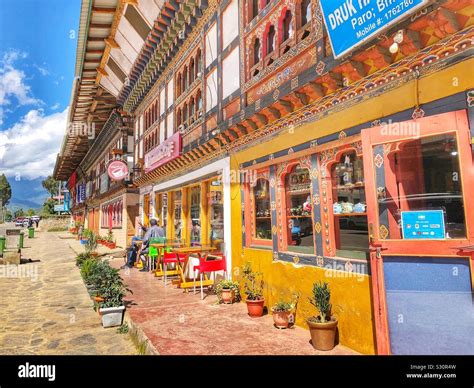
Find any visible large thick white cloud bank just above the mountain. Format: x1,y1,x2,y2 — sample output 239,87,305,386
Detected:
0,108,67,179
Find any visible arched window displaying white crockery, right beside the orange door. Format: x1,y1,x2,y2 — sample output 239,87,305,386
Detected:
331,151,369,259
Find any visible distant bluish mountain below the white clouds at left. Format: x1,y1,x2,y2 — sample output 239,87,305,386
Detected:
7,177,49,210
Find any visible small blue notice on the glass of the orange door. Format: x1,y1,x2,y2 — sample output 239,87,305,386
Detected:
402,210,446,240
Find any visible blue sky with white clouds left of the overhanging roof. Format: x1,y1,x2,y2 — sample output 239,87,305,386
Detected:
0,0,81,209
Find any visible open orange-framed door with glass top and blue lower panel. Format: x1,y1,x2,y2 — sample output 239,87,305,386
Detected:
362,111,474,354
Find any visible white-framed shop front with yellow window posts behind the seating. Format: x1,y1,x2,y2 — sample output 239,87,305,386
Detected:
141,158,232,270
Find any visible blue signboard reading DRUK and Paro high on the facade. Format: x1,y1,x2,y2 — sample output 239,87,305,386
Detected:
320,0,428,58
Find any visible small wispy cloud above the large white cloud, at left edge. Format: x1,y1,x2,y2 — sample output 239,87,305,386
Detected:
0,50,43,125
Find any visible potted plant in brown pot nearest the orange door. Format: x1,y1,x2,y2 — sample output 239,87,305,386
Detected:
307,282,337,350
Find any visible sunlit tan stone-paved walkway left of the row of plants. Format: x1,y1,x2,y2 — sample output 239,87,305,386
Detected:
0,232,137,355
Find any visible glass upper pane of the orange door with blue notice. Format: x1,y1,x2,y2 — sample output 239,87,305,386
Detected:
374,134,466,239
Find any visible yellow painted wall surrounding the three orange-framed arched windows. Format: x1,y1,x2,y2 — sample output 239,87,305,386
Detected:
231,59,474,354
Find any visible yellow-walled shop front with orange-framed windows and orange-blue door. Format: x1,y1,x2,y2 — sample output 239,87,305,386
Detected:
231,63,474,354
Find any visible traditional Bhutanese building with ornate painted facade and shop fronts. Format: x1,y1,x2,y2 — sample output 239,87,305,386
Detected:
54,0,474,354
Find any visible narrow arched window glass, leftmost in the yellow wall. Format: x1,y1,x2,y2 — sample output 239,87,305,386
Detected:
252,178,272,240
